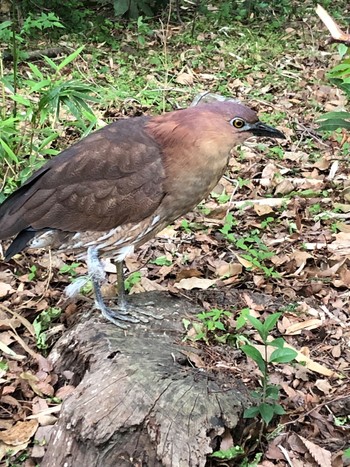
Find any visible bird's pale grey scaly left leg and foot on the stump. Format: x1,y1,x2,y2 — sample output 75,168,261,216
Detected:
87,247,140,329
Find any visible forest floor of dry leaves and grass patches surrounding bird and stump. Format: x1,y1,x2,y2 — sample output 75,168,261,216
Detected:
0,4,350,467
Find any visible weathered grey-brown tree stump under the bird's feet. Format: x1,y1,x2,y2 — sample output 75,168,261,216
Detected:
41,293,249,467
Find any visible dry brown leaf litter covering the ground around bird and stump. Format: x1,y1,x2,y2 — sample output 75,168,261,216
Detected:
0,7,350,467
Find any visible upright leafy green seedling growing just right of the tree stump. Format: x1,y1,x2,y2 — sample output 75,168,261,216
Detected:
241,313,297,425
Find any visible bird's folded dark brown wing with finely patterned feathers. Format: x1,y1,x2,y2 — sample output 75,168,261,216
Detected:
0,118,164,238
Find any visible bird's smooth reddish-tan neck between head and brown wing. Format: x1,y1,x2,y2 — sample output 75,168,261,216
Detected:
146,112,234,221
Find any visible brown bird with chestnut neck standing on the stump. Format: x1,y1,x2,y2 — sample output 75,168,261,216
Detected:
0,100,285,328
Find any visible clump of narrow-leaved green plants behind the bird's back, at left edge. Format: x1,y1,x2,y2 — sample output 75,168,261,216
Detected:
0,40,99,194
